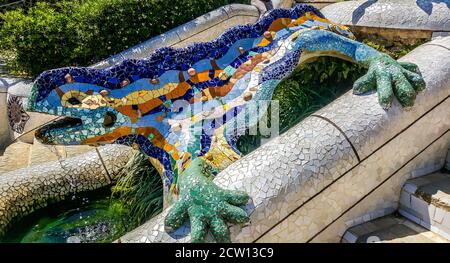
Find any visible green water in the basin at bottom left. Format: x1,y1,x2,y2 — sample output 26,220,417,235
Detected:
0,189,128,243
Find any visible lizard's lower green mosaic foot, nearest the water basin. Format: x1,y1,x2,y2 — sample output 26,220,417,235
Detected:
165,158,249,243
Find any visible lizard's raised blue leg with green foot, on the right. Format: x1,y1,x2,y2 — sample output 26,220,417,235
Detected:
293,30,425,109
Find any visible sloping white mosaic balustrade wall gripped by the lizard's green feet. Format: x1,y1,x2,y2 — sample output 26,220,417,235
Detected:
120,38,450,243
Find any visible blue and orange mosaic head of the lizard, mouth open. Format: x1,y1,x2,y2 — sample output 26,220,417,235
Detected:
28,68,131,145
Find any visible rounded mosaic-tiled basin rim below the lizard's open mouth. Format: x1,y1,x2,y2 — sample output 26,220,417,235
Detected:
0,145,133,235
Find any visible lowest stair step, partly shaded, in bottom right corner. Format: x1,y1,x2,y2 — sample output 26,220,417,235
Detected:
342,215,450,243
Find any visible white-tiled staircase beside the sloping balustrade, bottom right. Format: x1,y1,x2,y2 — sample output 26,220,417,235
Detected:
341,148,450,243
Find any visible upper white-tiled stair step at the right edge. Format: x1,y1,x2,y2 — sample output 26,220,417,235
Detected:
399,172,450,239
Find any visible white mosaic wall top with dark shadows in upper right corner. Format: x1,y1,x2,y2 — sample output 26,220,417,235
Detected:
321,0,450,38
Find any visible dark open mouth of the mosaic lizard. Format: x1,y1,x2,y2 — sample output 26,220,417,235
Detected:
35,117,83,144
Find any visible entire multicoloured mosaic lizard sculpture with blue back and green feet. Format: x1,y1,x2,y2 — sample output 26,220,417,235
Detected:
28,5,425,242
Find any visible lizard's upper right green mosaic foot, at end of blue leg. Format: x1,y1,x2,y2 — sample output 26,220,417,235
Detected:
353,54,425,109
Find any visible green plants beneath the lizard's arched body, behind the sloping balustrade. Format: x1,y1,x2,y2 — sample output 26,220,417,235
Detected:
237,57,365,154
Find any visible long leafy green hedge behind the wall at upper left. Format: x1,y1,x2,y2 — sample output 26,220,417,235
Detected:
0,0,249,76
